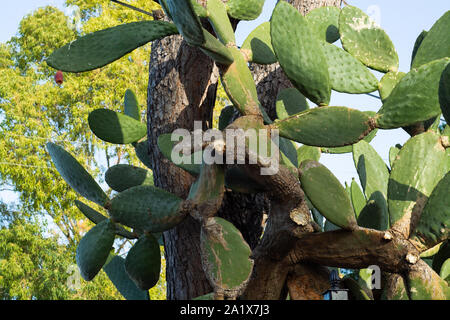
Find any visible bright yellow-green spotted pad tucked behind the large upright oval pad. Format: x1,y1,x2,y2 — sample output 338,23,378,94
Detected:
320,41,378,93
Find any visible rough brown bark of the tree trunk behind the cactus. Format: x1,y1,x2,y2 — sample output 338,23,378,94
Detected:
147,0,340,299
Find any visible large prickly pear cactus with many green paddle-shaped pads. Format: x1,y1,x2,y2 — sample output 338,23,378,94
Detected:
47,0,450,299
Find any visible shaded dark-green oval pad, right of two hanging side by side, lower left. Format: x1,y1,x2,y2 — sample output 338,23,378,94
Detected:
125,234,161,290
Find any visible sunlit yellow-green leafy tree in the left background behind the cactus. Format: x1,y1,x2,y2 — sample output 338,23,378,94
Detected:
0,0,175,299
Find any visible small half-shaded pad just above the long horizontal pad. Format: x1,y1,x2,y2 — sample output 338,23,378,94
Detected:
276,88,309,120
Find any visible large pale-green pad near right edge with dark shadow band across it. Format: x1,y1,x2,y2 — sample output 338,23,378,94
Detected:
388,132,447,226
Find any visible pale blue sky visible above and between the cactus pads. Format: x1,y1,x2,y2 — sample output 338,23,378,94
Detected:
0,0,450,199
